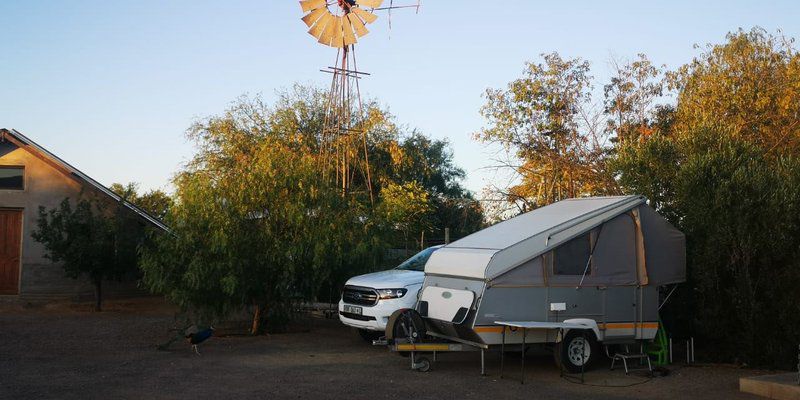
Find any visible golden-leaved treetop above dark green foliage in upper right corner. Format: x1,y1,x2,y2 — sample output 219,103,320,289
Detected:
670,28,800,154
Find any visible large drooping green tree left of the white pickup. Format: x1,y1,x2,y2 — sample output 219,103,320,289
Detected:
142,97,380,334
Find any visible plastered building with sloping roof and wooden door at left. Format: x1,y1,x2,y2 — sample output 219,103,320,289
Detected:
0,129,167,300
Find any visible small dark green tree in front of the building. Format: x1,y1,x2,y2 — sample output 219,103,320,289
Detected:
31,196,144,311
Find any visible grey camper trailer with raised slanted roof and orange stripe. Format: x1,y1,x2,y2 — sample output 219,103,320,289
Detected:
386,196,686,371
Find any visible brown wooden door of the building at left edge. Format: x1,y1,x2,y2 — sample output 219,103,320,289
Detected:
0,210,22,294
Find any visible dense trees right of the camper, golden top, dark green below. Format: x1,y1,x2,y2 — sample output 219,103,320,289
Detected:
610,29,800,367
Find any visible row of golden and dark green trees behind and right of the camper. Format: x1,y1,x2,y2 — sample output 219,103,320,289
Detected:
477,28,800,367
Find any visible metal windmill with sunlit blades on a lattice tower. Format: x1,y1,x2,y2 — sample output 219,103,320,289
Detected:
300,0,419,201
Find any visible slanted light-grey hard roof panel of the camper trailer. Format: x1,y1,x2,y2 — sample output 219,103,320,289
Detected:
425,196,646,279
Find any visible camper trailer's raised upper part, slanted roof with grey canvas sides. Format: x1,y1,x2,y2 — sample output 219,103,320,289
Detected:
425,196,685,287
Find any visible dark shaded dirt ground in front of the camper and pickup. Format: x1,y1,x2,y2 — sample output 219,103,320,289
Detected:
0,300,766,400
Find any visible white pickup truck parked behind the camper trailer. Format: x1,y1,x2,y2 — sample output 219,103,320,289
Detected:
339,246,442,340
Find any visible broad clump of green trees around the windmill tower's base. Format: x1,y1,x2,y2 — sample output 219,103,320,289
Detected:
142,86,482,333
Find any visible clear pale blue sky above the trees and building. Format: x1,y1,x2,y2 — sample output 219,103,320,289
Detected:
0,0,800,198
